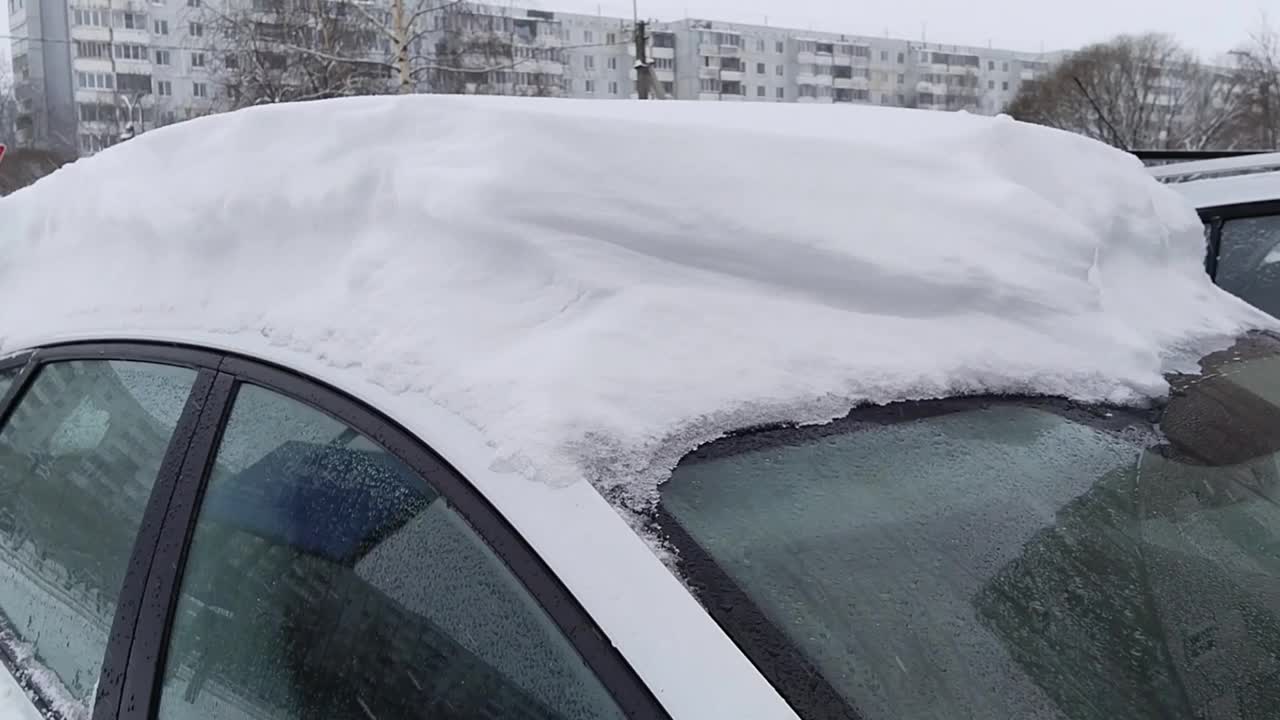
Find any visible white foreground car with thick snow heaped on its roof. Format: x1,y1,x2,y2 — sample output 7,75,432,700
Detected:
0,96,1280,720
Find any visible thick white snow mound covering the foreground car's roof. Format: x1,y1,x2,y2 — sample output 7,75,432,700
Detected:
0,96,1268,505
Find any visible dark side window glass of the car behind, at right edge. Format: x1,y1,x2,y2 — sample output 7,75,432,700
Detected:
1216,215,1280,316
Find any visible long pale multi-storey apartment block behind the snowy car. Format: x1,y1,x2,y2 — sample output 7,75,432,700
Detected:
8,0,1057,155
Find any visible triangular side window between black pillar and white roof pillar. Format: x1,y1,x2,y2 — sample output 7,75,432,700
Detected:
160,384,622,720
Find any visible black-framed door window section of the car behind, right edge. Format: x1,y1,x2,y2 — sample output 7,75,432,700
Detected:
1201,200,1280,316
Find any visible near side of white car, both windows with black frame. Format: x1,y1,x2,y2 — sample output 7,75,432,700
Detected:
0,343,666,720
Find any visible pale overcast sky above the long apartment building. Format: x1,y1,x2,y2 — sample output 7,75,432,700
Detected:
540,0,1280,59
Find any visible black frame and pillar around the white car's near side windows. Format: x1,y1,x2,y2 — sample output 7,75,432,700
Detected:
0,341,671,720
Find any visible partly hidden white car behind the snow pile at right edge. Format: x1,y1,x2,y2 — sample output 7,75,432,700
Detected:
1151,152,1280,316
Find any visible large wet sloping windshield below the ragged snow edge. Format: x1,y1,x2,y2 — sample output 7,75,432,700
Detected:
658,337,1280,720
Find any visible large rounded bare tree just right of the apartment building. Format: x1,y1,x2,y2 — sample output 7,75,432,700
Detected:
1007,35,1244,150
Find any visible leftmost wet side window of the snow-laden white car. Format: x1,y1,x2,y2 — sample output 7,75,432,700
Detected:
0,361,196,716
